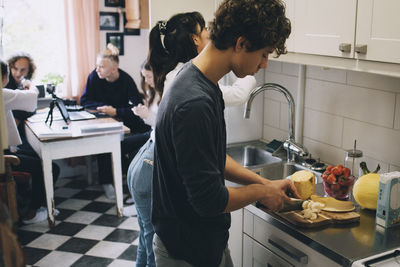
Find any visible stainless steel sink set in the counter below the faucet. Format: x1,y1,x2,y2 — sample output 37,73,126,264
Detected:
227,141,322,183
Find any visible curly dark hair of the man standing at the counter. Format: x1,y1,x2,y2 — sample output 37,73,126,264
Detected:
210,0,291,56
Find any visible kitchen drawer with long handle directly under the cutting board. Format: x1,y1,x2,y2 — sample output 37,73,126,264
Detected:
243,210,341,267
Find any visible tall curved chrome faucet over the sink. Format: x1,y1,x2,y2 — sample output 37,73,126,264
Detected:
244,83,308,161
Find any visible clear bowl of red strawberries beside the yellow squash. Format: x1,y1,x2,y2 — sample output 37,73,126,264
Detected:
322,165,355,200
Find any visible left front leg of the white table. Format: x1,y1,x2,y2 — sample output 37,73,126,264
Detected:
42,151,55,228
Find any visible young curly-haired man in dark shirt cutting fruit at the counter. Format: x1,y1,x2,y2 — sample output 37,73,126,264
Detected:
152,0,299,267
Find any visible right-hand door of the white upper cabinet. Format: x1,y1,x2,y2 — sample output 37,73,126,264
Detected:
355,0,400,63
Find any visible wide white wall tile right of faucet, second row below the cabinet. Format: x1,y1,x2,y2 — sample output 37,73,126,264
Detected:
305,79,395,128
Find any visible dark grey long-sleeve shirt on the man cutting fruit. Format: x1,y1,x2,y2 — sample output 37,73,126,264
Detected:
152,62,230,266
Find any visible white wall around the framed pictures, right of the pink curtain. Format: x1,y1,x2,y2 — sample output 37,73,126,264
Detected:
98,0,149,87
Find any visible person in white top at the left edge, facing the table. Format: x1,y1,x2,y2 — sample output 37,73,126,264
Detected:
0,60,60,224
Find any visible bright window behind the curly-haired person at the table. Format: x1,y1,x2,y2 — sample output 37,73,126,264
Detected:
0,0,67,87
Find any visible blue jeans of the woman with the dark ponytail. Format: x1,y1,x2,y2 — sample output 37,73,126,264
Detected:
127,139,156,267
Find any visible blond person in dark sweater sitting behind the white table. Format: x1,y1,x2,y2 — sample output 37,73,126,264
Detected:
80,44,150,199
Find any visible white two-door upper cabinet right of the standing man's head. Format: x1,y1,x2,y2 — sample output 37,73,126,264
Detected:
286,0,400,63
